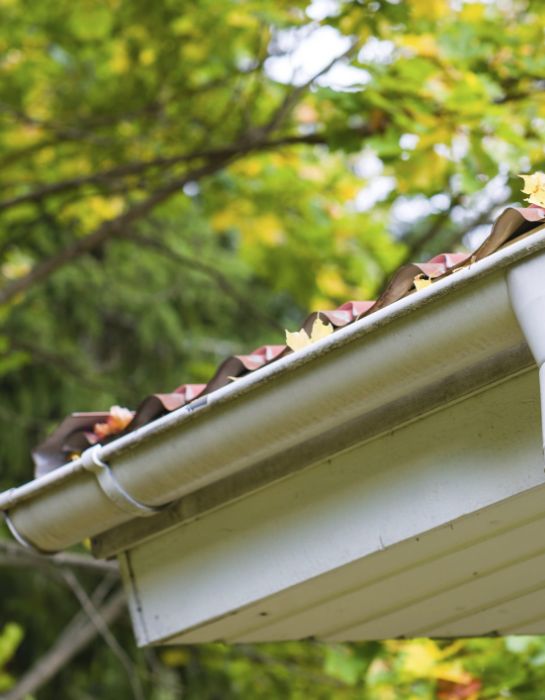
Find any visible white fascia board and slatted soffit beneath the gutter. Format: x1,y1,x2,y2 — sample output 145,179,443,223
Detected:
123,370,545,644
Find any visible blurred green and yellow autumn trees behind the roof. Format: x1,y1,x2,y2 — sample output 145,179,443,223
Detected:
0,0,545,700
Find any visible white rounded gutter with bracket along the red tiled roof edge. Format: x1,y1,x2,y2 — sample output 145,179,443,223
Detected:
0,230,545,552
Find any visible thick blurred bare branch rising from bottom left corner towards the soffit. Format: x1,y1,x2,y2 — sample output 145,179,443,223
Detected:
2,590,125,700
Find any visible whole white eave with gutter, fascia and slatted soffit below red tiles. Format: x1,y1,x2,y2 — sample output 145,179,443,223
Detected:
5,229,545,645
